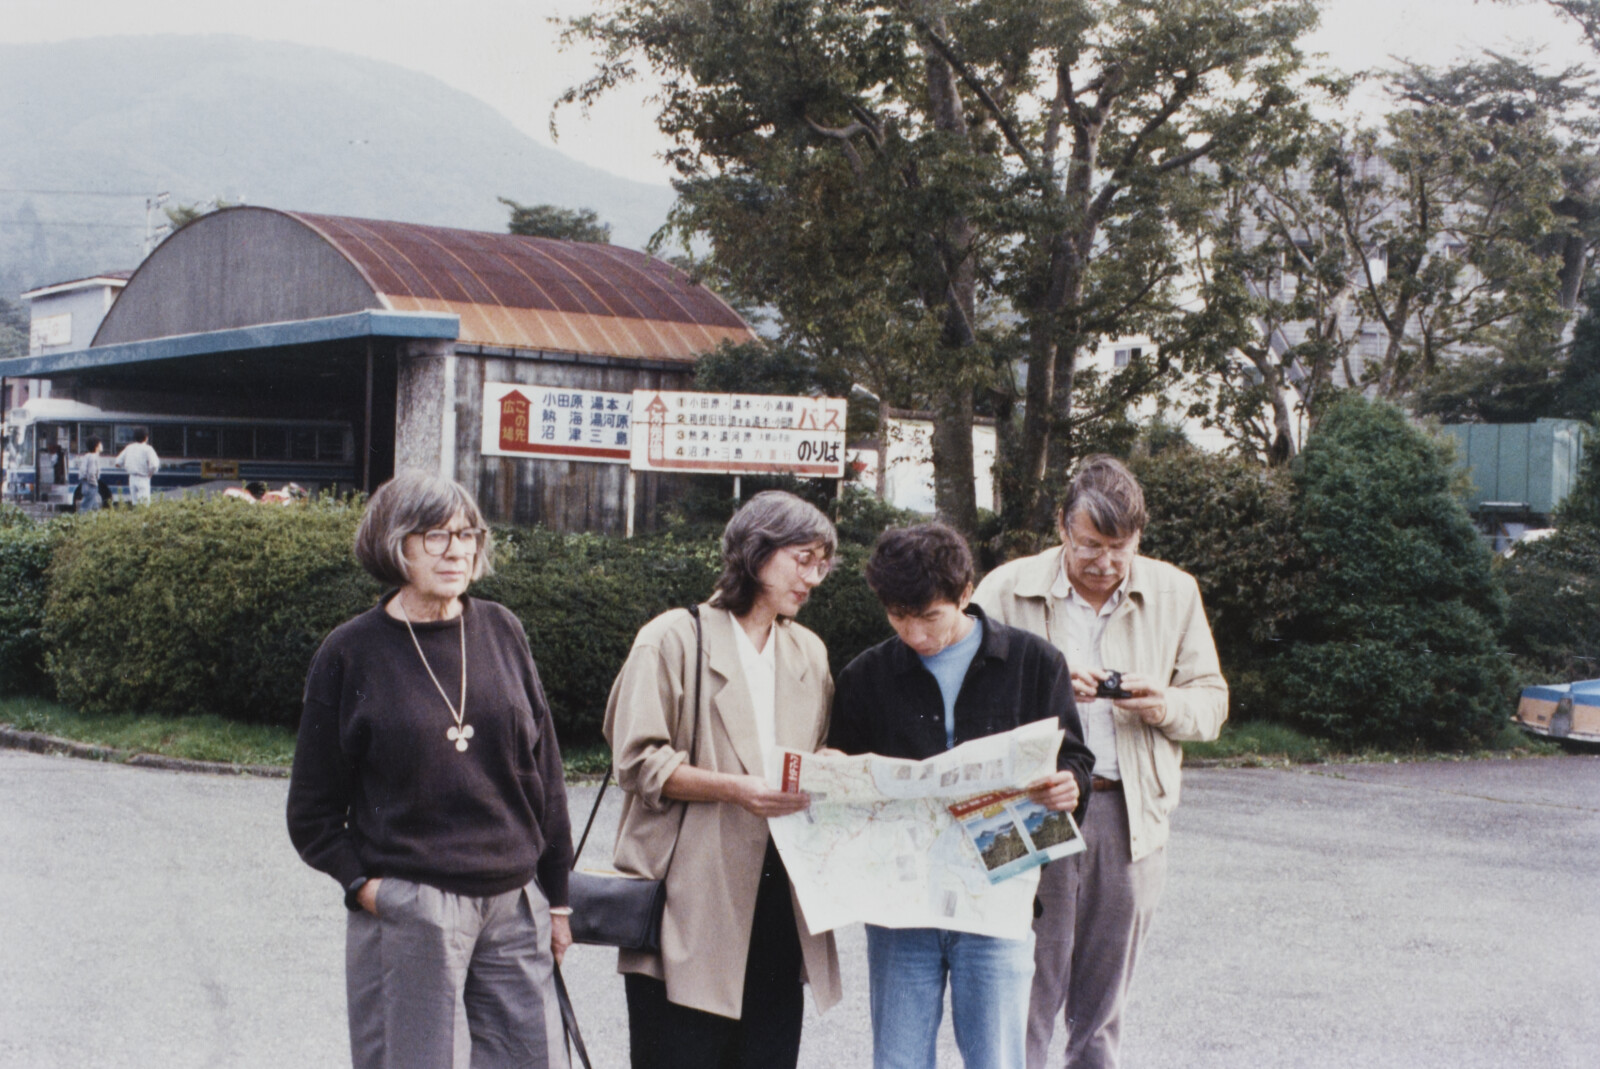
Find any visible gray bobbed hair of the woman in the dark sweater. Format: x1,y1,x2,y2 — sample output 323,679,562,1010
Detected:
355,470,494,586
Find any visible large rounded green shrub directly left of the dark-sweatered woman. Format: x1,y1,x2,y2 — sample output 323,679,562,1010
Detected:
45,498,378,725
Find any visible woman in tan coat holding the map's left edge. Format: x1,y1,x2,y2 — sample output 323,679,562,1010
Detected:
605,491,838,1069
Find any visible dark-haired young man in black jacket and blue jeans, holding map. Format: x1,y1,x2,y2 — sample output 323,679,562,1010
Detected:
829,523,1094,1069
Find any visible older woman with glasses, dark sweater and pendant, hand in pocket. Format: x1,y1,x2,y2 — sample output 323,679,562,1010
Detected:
288,472,573,1069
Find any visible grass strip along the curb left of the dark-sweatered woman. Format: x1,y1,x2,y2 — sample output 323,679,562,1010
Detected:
0,698,294,765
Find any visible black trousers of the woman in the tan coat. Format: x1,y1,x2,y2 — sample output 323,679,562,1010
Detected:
622,840,805,1069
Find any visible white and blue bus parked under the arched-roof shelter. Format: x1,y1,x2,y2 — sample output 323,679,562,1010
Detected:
0,397,358,506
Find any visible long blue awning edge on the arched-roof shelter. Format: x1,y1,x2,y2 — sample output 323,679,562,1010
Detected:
0,310,461,379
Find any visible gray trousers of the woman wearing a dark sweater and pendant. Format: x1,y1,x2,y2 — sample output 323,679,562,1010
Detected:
344,877,568,1069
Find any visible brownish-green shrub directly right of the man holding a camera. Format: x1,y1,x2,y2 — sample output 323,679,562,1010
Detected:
1131,446,1312,720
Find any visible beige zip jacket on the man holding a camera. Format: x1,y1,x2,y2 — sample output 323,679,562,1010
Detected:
973,546,1227,861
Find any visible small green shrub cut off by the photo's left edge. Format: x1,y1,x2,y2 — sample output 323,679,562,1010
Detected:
0,506,62,696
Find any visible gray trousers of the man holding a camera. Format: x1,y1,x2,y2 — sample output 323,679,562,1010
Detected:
1027,791,1166,1069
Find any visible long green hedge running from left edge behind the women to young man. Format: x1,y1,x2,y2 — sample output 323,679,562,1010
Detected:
25,498,890,743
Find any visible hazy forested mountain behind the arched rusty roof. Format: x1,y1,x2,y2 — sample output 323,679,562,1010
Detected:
0,35,672,299
